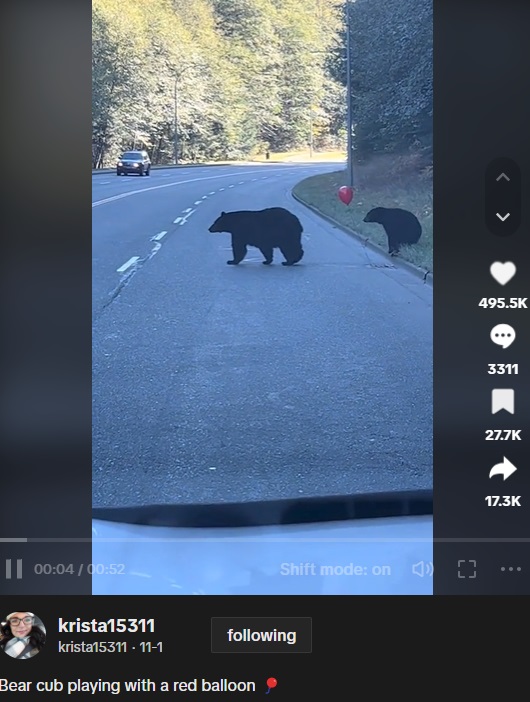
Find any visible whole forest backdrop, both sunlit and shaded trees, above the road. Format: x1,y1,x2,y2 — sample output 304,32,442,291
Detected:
92,0,433,169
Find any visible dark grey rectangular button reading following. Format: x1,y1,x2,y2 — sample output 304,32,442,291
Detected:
212,617,312,653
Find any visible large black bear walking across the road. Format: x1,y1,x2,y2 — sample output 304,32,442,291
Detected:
208,207,304,266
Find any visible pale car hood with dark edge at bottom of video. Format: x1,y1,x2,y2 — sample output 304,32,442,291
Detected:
92,492,433,595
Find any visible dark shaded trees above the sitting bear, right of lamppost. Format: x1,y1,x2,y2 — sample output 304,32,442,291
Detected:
351,0,433,159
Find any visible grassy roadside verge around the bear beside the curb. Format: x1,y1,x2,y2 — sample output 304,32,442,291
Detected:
293,155,433,271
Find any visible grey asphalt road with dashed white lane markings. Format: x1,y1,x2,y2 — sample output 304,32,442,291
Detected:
92,164,432,506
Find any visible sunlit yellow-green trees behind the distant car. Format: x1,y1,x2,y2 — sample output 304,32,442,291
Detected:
92,0,344,166
